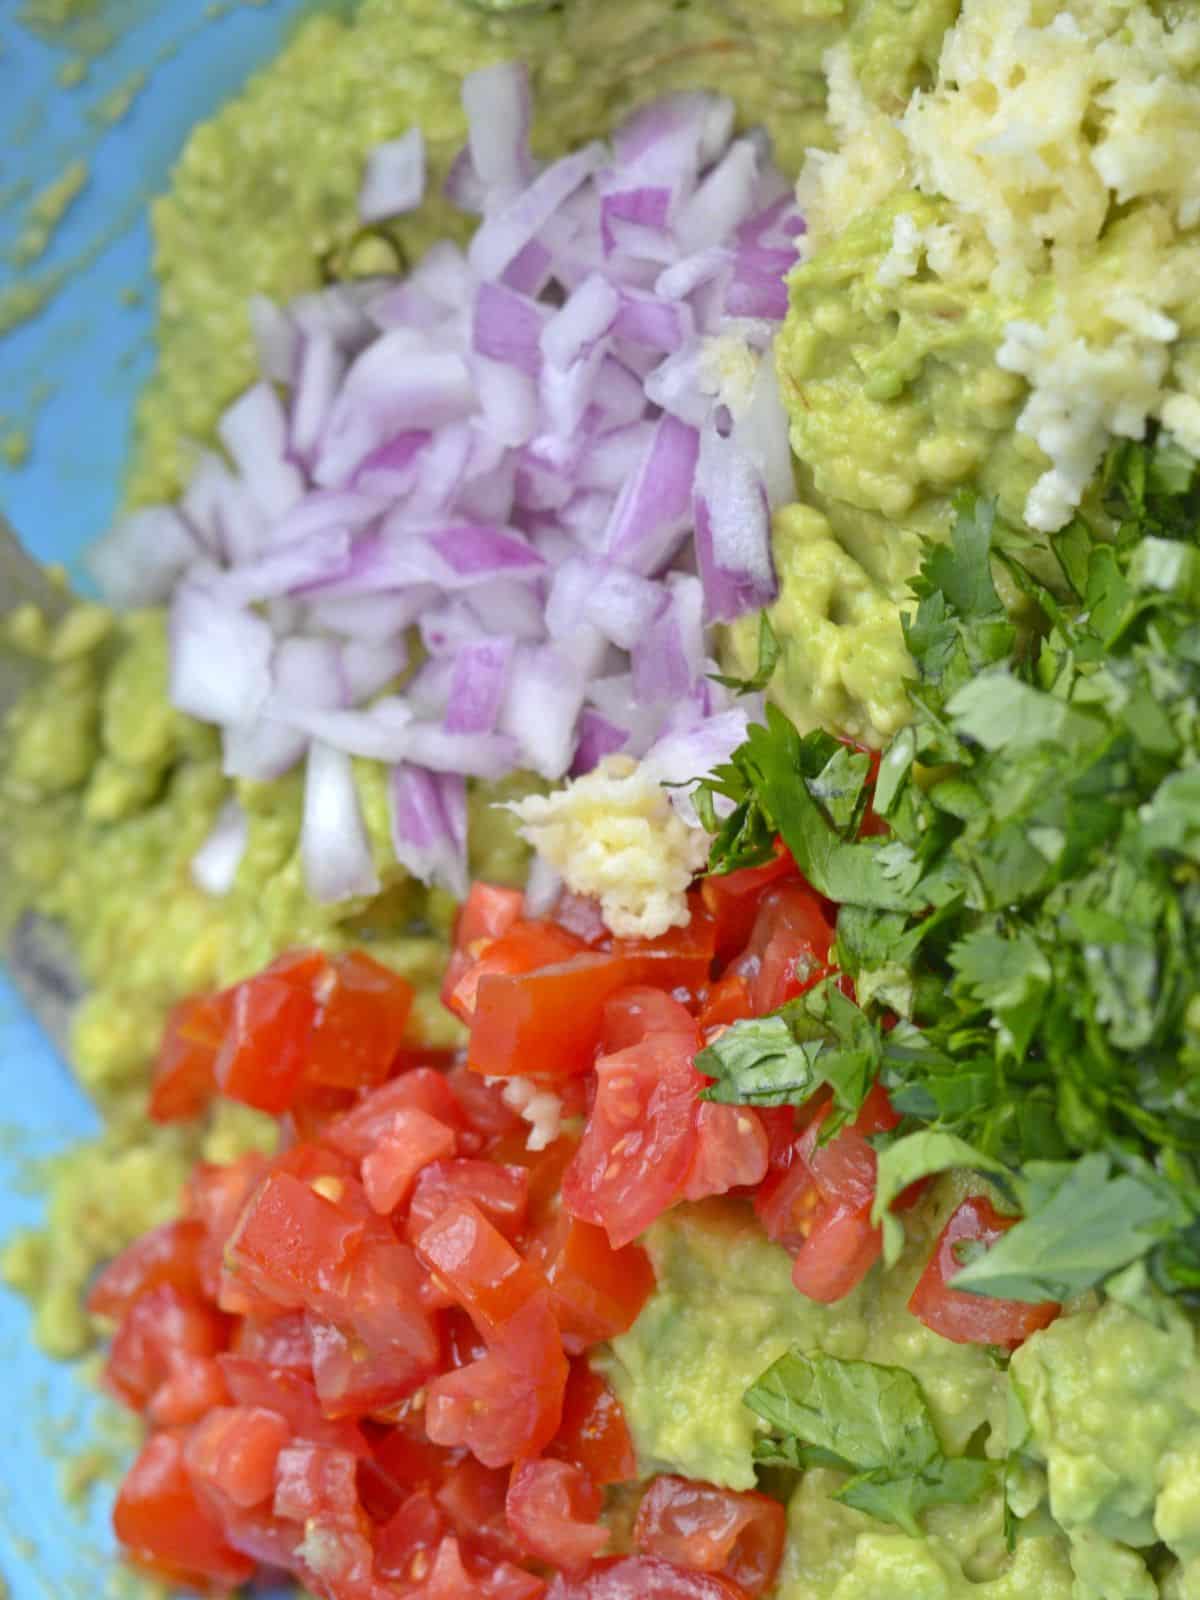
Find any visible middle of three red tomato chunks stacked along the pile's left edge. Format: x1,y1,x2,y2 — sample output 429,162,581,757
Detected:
104,1283,229,1422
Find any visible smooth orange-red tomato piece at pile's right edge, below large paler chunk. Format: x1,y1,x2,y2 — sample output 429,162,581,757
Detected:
530,1210,654,1352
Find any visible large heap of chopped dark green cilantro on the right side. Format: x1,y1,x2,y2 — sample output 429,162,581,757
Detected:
701,442,1200,1299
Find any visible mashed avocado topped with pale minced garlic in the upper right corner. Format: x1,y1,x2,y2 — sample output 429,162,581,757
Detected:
730,0,1200,744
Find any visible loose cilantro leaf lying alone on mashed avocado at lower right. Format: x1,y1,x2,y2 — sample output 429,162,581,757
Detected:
746,1349,1003,1536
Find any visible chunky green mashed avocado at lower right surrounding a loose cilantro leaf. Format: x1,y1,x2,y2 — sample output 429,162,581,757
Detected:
614,1203,1200,1600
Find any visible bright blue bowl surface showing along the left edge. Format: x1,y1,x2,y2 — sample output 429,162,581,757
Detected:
0,9,324,1600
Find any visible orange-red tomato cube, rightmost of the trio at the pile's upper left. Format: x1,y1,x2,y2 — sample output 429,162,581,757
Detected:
304,950,413,1090
